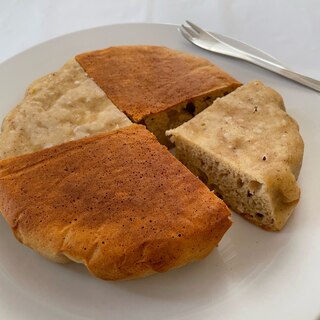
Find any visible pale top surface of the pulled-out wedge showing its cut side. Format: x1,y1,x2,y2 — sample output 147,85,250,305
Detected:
167,81,303,188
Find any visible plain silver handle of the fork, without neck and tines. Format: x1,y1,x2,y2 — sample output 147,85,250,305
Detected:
241,54,320,92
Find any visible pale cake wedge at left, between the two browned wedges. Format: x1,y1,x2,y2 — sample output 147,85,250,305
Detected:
0,59,131,159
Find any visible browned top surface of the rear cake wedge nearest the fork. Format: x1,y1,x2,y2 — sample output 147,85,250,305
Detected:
76,46,240,122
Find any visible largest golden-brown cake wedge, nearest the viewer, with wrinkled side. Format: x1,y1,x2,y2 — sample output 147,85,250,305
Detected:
0,125,231,280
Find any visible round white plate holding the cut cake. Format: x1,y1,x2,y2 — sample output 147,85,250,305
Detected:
0,24,320,320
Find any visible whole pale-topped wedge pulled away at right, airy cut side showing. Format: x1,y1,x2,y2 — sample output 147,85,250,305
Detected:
167,81,304,230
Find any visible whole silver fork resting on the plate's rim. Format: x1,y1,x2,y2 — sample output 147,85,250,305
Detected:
178,21,320,92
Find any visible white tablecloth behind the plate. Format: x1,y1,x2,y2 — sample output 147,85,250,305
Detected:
0,0,320,79
